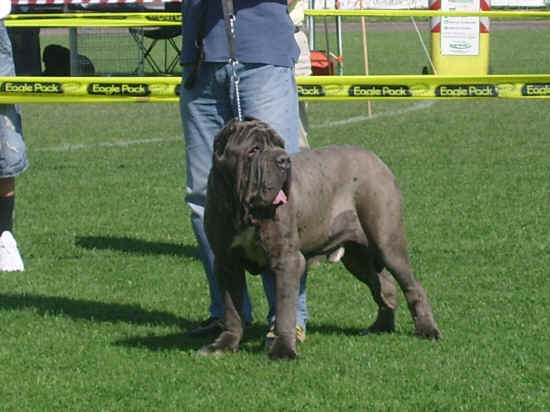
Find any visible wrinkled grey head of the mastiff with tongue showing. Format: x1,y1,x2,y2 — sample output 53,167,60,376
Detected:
213,118,291,224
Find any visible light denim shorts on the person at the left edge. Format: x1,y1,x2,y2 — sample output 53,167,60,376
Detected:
0,20,28,178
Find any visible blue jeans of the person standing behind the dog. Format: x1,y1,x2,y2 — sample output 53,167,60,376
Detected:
180,63,308,330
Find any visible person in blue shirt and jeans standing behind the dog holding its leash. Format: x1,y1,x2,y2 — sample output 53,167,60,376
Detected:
180,0,308,342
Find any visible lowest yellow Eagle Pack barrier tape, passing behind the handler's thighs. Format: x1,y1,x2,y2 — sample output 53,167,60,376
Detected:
0,74,550,104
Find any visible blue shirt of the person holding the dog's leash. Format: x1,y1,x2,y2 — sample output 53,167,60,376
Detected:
181,0,300,67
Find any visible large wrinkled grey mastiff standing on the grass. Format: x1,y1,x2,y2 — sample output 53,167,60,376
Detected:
200,119,441,359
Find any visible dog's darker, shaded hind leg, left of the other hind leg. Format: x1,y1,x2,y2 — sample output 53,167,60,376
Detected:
342,243,397,334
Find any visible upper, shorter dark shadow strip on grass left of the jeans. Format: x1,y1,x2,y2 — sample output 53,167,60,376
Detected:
75,236,199,259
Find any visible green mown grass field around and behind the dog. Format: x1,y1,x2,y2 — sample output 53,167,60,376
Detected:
0,23,550,412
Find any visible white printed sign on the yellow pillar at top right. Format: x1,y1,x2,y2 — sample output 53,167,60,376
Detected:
441,0,479,56
